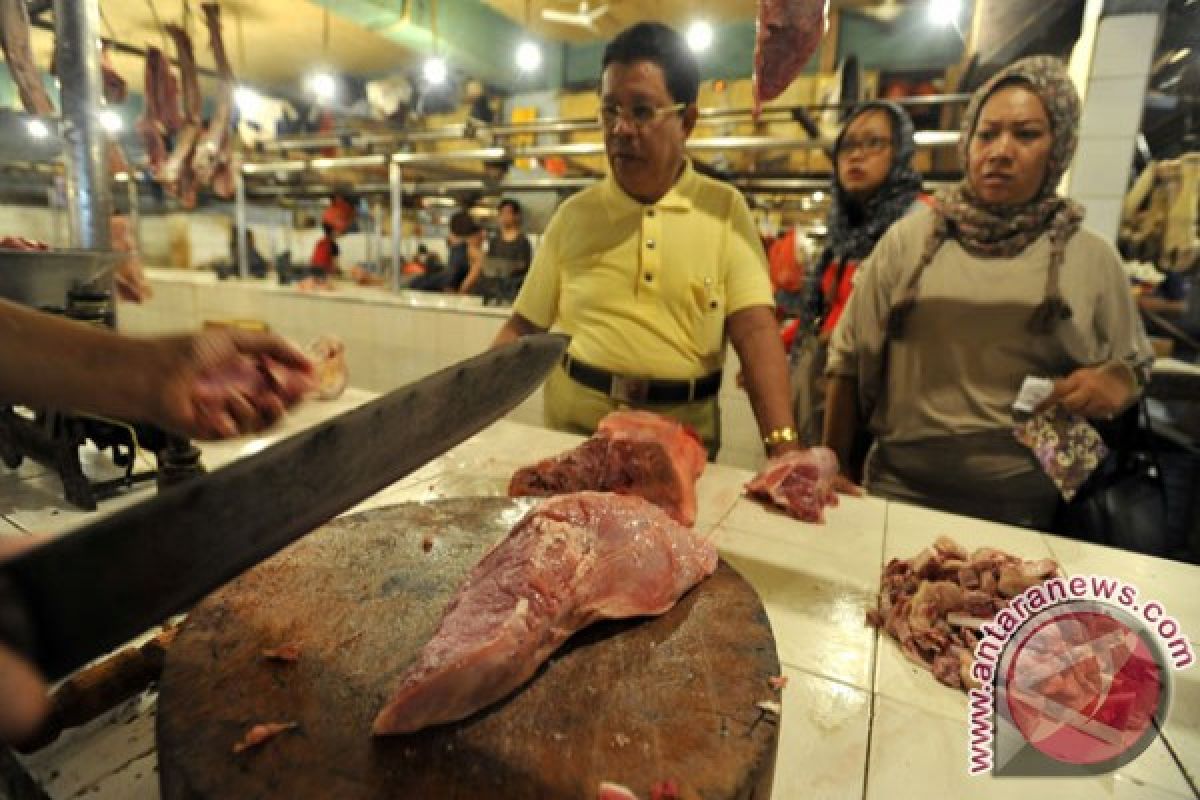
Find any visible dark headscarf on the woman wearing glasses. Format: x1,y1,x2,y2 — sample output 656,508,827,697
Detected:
826,100,920,260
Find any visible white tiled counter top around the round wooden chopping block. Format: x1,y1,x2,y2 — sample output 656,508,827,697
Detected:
0,390,1200,800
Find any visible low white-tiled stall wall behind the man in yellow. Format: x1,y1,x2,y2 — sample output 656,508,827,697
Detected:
119,270,762,469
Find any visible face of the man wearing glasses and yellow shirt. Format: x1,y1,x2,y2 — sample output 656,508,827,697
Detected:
600,61,696,203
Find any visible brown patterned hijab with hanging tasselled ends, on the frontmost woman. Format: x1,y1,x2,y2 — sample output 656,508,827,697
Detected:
888,55,1084,338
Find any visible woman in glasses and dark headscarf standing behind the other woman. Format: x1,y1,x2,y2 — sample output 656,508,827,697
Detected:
791,101,928,448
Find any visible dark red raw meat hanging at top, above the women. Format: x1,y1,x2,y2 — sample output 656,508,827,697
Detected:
754,0,828,119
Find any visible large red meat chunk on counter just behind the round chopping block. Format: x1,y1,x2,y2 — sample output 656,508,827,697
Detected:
509,411,706,525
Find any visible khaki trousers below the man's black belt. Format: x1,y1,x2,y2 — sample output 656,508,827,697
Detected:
544,365,721,461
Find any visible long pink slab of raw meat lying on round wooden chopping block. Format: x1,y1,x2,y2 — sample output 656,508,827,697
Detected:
374,492,716,735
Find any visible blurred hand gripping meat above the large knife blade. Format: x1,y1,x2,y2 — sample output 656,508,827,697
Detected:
156,331,316,439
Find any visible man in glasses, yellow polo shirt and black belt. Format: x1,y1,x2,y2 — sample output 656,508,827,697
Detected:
496,23,796,457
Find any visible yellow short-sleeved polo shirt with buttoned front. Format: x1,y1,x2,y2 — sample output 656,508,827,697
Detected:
514,161,774,379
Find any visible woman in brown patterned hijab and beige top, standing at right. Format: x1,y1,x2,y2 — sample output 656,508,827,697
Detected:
824,56,1152,529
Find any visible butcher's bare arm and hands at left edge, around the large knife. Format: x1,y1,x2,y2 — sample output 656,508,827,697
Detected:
0,301,316,742
